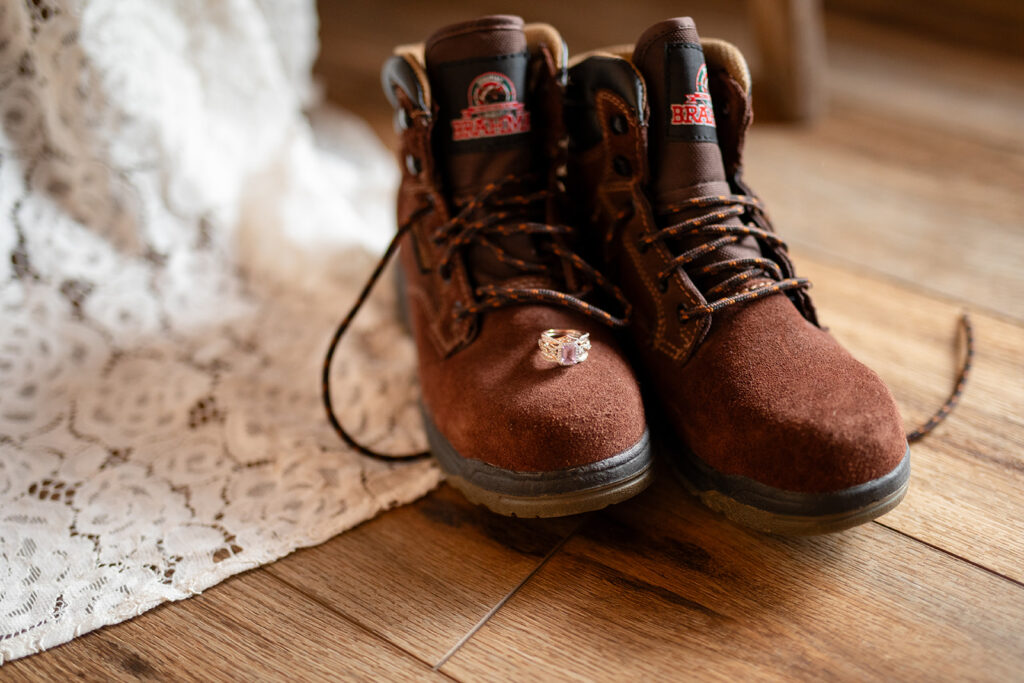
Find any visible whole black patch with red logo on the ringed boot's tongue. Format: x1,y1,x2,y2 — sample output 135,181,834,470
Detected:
442,52,529,152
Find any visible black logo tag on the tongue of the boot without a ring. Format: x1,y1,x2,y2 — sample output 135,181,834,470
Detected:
665,43,718,142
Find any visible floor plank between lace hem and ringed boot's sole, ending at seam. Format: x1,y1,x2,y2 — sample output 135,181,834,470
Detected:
267,487,579,663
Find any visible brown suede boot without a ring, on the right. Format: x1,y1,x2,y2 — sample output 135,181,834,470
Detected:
565,18,910,535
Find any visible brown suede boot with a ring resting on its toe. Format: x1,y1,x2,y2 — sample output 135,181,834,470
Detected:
344,15,651,517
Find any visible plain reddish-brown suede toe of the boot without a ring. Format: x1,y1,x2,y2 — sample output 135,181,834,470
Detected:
672,295,907,494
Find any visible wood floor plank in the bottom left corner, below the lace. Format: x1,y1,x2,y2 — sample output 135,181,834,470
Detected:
0,570,444,682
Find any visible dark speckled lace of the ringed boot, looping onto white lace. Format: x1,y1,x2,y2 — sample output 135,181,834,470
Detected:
322,176,632,460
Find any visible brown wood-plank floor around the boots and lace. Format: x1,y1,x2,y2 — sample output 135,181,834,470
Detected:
9,1,1024,681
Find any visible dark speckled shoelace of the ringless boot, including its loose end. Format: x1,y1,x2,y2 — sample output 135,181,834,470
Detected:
640,195,974,443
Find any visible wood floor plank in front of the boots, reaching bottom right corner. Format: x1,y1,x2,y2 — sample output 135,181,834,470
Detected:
441,478,1024,681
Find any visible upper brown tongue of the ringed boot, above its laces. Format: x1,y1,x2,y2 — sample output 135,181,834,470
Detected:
424,15,534,204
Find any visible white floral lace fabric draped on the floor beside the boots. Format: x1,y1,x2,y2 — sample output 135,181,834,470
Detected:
0,0,439,664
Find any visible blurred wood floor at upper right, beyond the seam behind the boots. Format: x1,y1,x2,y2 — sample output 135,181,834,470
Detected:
745,17,1024,319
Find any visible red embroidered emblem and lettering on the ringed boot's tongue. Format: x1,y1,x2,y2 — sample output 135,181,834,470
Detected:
452,71,529,142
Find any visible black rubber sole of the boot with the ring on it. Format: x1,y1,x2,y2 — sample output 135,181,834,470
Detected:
423,411,653,517
